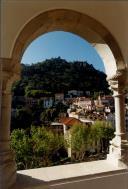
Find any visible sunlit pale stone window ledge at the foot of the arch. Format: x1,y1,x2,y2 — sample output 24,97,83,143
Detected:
13,160,128,189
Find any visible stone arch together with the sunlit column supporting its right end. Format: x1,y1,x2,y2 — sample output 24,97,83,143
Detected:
11,9,128,165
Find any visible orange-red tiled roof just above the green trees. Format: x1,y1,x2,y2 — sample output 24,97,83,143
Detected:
60,117,82,126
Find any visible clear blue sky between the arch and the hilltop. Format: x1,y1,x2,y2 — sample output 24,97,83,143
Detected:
21,31,104,71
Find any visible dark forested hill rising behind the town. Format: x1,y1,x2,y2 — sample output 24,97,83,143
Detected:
13,57,108,96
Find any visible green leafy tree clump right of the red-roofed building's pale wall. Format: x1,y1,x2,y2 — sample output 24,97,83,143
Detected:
69,121,114,161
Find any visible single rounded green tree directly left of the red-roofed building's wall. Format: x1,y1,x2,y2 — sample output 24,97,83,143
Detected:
31,127,64,166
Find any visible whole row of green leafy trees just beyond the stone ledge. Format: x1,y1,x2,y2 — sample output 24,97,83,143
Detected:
11,122,114,169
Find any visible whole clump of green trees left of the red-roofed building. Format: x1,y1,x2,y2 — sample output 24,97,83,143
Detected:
11,126,66,169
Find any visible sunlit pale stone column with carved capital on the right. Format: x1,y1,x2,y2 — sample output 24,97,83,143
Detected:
107,71,128,168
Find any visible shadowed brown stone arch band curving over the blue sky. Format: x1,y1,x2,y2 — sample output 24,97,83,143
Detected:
12,9,125,74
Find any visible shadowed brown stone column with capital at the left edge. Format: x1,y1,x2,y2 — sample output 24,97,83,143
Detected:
0,58,20,189
